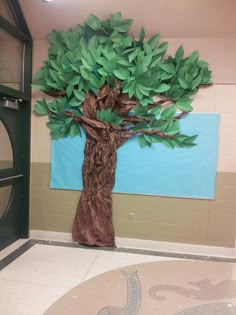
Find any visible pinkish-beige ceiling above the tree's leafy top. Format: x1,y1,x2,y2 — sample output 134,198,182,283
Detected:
19,0,236,39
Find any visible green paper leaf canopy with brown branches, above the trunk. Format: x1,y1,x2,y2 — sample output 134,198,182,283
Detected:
33,13,211,148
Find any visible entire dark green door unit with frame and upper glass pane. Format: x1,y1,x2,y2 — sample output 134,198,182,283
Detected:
0,0,32,250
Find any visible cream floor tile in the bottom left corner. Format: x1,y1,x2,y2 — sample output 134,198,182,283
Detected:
0,280,68,315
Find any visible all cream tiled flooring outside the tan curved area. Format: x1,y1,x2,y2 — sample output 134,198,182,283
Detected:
0,240,175,315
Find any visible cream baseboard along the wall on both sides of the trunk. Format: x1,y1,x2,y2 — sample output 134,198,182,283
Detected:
30,230,236,258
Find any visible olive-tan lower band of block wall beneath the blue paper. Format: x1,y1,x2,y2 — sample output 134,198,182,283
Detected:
31,163,236,246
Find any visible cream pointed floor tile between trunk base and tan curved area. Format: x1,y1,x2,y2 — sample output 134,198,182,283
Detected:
84,251,176,281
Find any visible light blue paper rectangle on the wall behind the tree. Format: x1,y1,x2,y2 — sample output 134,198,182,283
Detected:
50,113,219,199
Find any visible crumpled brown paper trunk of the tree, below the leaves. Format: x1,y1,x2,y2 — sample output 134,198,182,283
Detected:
72,133,116,247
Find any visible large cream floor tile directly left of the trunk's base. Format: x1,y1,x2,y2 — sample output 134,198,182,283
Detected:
0,244,99,288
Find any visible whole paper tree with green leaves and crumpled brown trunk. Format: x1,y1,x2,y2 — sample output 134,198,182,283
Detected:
33,13,211,246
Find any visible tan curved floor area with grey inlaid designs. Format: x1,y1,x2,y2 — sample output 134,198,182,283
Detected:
44,260,236,315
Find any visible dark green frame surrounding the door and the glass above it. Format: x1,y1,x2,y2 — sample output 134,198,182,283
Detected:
0,0,33,238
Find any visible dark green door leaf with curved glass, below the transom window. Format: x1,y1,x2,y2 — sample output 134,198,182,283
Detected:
0,100,28,249
